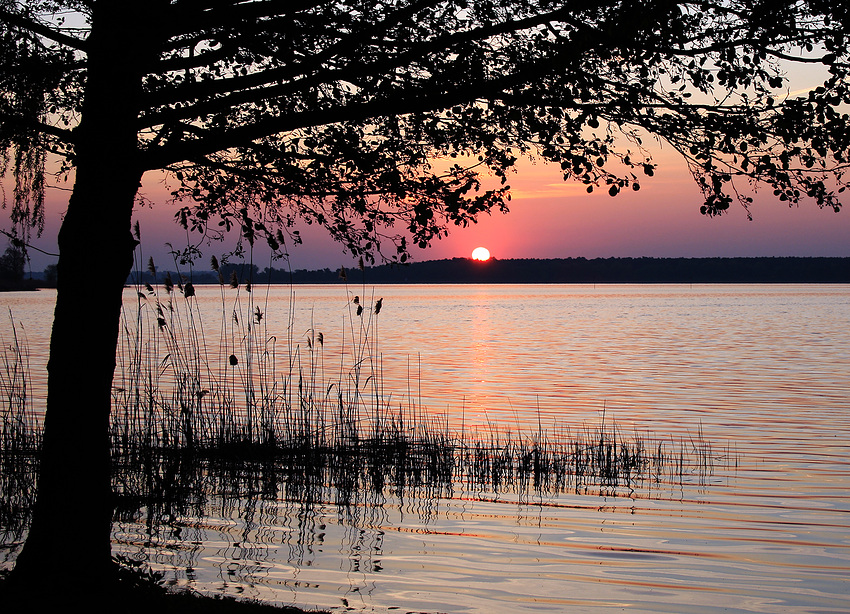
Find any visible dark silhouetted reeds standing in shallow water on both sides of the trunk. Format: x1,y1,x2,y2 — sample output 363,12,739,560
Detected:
0,261,721,564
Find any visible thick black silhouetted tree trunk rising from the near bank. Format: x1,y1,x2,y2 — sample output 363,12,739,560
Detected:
9,2,147,601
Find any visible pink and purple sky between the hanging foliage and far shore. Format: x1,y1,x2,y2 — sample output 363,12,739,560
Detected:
24,150,850,271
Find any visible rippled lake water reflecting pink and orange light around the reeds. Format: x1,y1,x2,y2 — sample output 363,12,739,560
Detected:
3,285,850,614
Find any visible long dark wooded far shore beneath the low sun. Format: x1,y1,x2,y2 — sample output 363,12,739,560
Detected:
122,257,850,284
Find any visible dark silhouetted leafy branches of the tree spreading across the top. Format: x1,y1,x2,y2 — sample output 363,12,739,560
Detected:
0,0,850,259
